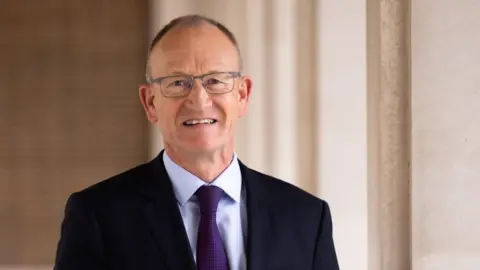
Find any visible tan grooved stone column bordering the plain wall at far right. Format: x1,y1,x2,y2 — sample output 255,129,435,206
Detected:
367,0,411,270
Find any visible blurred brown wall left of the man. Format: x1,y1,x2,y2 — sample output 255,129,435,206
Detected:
0,0,149,269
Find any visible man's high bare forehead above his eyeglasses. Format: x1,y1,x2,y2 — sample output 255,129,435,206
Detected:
150,24,239,75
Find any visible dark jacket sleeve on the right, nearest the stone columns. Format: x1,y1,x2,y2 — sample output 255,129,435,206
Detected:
313,202,340,270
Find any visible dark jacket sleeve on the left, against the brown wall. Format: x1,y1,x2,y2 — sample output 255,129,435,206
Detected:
54,193,105,270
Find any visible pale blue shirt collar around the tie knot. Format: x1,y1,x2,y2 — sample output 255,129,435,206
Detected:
163,151,242,205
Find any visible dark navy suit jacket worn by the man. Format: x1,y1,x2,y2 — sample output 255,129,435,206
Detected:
54,154,339,270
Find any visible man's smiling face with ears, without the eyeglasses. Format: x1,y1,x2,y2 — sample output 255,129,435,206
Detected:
140,24,251,155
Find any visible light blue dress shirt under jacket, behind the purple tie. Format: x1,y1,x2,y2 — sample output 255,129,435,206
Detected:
163,152,247,270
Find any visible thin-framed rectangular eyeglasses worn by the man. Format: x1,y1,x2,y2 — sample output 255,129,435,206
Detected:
149,72,242,97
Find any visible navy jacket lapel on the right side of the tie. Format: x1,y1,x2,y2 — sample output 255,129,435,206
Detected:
240,163,278,270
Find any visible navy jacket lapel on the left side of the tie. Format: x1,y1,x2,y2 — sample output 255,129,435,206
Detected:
138,152,196,270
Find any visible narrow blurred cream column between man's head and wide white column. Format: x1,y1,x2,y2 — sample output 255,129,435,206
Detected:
267,0,297,183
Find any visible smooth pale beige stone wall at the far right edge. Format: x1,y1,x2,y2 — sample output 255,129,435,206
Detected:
412,0,480,270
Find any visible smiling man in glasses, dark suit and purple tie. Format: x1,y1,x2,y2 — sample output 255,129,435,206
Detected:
55,15,339,270
